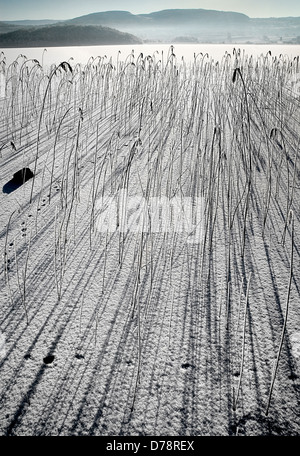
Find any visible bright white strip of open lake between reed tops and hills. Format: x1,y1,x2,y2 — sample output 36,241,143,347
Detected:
2,43,300,65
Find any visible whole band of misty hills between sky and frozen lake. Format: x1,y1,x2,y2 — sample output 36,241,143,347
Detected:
0,8,300,47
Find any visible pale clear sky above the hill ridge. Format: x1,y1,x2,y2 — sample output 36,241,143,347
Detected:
0,0,300,21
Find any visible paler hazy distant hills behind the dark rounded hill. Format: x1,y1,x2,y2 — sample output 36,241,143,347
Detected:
66,9,300,42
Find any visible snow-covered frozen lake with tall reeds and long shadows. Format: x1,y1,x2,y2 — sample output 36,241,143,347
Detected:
0,37,300,436
